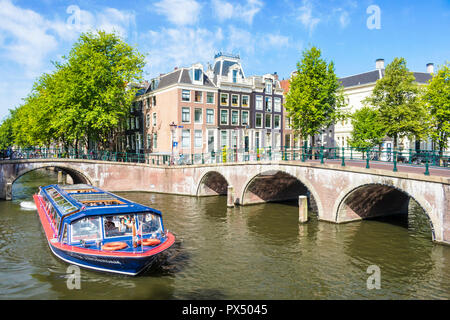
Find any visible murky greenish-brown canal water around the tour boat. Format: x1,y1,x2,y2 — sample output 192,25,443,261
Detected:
0,171,450,300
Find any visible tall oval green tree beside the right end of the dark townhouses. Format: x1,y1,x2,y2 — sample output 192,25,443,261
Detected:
285,47,344,146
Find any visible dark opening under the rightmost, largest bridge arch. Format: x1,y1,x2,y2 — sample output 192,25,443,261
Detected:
336,184,435,239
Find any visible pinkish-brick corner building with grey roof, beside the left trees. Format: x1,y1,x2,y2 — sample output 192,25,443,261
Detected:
138,64,218,155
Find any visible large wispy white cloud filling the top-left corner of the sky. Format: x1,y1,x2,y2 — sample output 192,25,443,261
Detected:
0,0,134,78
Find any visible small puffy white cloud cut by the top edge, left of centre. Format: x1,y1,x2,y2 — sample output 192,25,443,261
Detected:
154,0,201,26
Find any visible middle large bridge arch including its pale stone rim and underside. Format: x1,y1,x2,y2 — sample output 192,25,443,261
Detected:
240,168,323,218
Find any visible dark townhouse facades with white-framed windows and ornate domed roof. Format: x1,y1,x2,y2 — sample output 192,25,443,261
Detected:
207,53,283,152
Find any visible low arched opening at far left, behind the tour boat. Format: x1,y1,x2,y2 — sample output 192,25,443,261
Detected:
6,166,91,200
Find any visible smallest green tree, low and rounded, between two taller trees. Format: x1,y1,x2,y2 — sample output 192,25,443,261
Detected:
349,106,386,150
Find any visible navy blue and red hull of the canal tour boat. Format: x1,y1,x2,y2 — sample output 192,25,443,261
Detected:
33,195,175,276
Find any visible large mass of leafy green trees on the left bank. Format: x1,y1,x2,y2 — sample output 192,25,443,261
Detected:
0,31,145,150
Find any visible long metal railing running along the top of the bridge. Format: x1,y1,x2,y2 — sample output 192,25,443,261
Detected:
0,145,450,175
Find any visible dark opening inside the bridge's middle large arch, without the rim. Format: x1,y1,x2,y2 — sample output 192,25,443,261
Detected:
242,170,318,212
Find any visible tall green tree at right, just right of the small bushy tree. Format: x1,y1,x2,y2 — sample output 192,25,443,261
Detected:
365,58,428,148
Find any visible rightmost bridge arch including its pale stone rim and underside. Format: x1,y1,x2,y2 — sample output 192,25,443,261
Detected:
334,182,440,240
